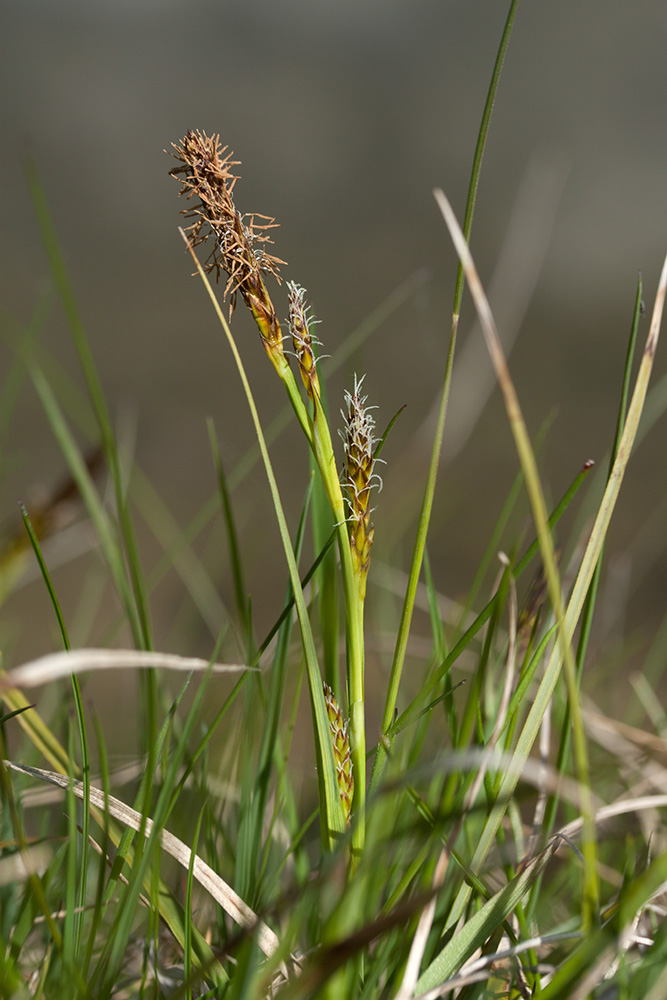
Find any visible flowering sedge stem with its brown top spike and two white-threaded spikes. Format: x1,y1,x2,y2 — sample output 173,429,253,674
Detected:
171,130,379,857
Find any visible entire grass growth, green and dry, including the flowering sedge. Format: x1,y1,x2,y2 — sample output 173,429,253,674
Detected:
0,3,667,1000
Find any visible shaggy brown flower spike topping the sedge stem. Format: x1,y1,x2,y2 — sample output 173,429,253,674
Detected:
170,130,285,356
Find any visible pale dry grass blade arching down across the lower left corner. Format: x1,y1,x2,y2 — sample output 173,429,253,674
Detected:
4,760,280,956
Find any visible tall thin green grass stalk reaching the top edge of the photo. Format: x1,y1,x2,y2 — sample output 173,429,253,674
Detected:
371,0,519,788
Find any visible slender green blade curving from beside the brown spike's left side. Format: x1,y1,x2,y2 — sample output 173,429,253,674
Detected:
181,231,345,850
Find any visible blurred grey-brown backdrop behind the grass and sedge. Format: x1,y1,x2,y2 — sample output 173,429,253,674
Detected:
0,0,667,712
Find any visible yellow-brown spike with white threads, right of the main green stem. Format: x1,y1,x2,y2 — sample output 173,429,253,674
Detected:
339,375,382,589
